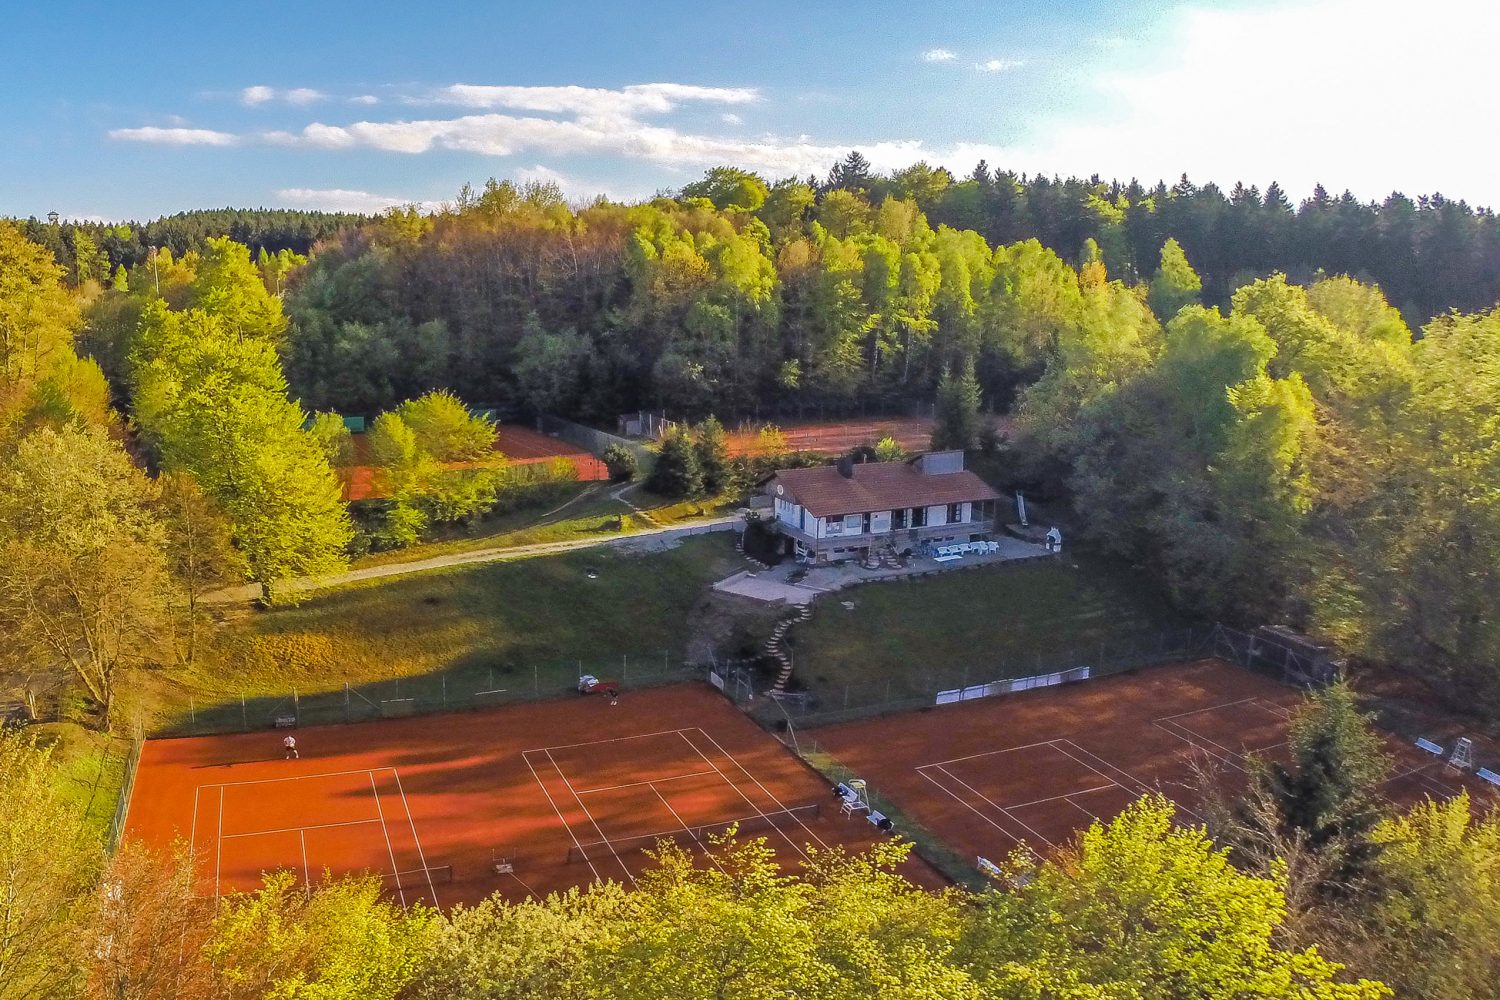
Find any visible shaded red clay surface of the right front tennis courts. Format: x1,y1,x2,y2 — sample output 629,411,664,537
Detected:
816,660,1500,861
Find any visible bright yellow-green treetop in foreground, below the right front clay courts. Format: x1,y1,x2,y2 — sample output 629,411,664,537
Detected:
962,796,1391,1000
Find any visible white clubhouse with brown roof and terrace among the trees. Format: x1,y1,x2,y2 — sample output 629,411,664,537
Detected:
764,451,1001,562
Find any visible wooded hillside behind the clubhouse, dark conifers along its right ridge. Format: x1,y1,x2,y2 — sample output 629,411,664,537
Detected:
276,153,1500,420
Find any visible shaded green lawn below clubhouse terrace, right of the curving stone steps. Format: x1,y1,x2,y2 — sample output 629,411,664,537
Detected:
791,552,1185,709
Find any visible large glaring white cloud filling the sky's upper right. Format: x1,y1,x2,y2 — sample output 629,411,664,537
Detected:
1011,0,1500,204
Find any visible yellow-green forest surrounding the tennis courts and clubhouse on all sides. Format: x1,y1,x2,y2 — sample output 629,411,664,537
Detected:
0,157,1500,1000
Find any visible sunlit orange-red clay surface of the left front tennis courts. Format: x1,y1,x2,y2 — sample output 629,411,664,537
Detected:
126,685,942,907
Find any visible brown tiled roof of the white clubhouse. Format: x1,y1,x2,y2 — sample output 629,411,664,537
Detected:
771,462,1001,517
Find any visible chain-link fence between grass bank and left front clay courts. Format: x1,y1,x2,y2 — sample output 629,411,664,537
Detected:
153,651,704,736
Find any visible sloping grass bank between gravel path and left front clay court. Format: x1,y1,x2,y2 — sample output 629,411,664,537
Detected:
159,534,741,732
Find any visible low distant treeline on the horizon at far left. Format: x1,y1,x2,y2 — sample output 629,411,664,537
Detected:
20,208,369,283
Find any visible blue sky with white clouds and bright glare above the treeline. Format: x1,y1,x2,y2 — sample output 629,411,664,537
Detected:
0,0,1500,219
